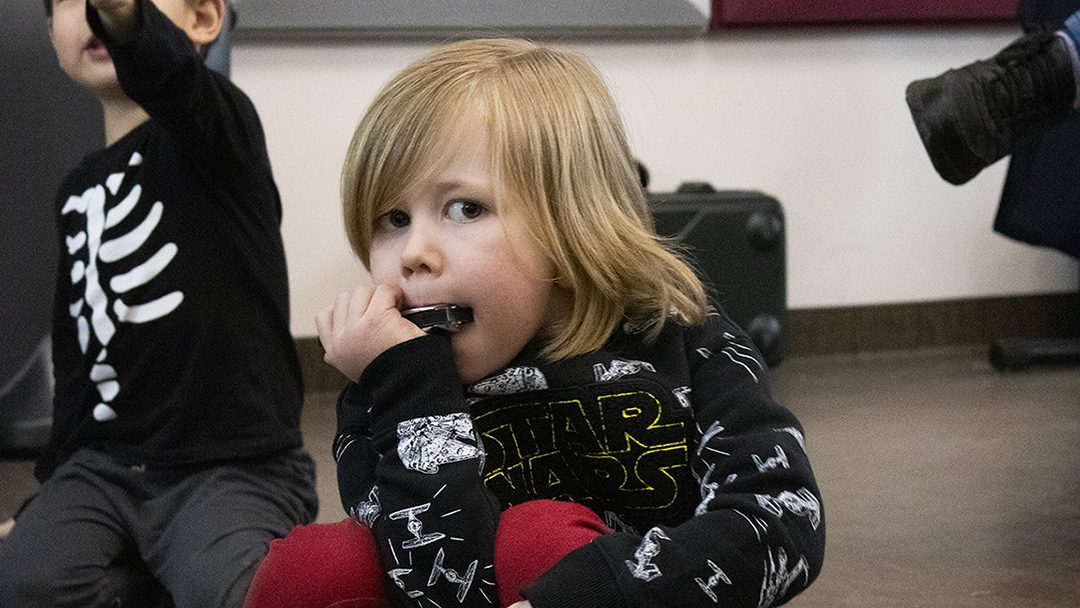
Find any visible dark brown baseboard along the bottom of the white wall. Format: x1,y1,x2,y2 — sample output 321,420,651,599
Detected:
296,293,1080,392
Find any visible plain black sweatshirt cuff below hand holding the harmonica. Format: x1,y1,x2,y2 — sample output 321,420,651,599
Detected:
357,334,468,433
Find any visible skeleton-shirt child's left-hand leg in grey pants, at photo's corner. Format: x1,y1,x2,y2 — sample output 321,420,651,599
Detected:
0,450,162,607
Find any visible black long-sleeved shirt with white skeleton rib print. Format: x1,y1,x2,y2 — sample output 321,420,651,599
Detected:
37,1,302,479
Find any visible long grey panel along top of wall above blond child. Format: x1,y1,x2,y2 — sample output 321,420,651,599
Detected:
235,0,710,38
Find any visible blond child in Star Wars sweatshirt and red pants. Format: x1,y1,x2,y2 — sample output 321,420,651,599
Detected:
248,40,825,608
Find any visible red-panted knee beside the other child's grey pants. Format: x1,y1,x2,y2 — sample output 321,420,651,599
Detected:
244,517,390,608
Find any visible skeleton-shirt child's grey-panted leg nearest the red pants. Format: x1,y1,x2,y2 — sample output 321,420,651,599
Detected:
145,449,318,608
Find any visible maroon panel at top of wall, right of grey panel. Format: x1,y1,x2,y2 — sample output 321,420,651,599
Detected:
711,0,1018,29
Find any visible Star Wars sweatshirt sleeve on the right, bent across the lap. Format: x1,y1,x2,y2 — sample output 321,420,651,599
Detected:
525,315,825,608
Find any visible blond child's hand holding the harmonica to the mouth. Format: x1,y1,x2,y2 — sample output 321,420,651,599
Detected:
315,285,424,382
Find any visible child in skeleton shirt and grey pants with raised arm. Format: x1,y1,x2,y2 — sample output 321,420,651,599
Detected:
0,0,318,608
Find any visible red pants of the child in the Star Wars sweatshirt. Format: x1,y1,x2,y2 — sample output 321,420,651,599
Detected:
244,500,610,608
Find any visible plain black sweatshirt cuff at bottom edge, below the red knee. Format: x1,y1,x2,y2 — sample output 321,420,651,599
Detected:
522,544,626,608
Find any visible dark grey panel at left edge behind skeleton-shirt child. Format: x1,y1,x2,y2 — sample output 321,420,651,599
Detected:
0,0,105,452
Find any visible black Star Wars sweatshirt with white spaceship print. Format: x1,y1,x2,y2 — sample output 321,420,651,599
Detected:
334,313,825,608
